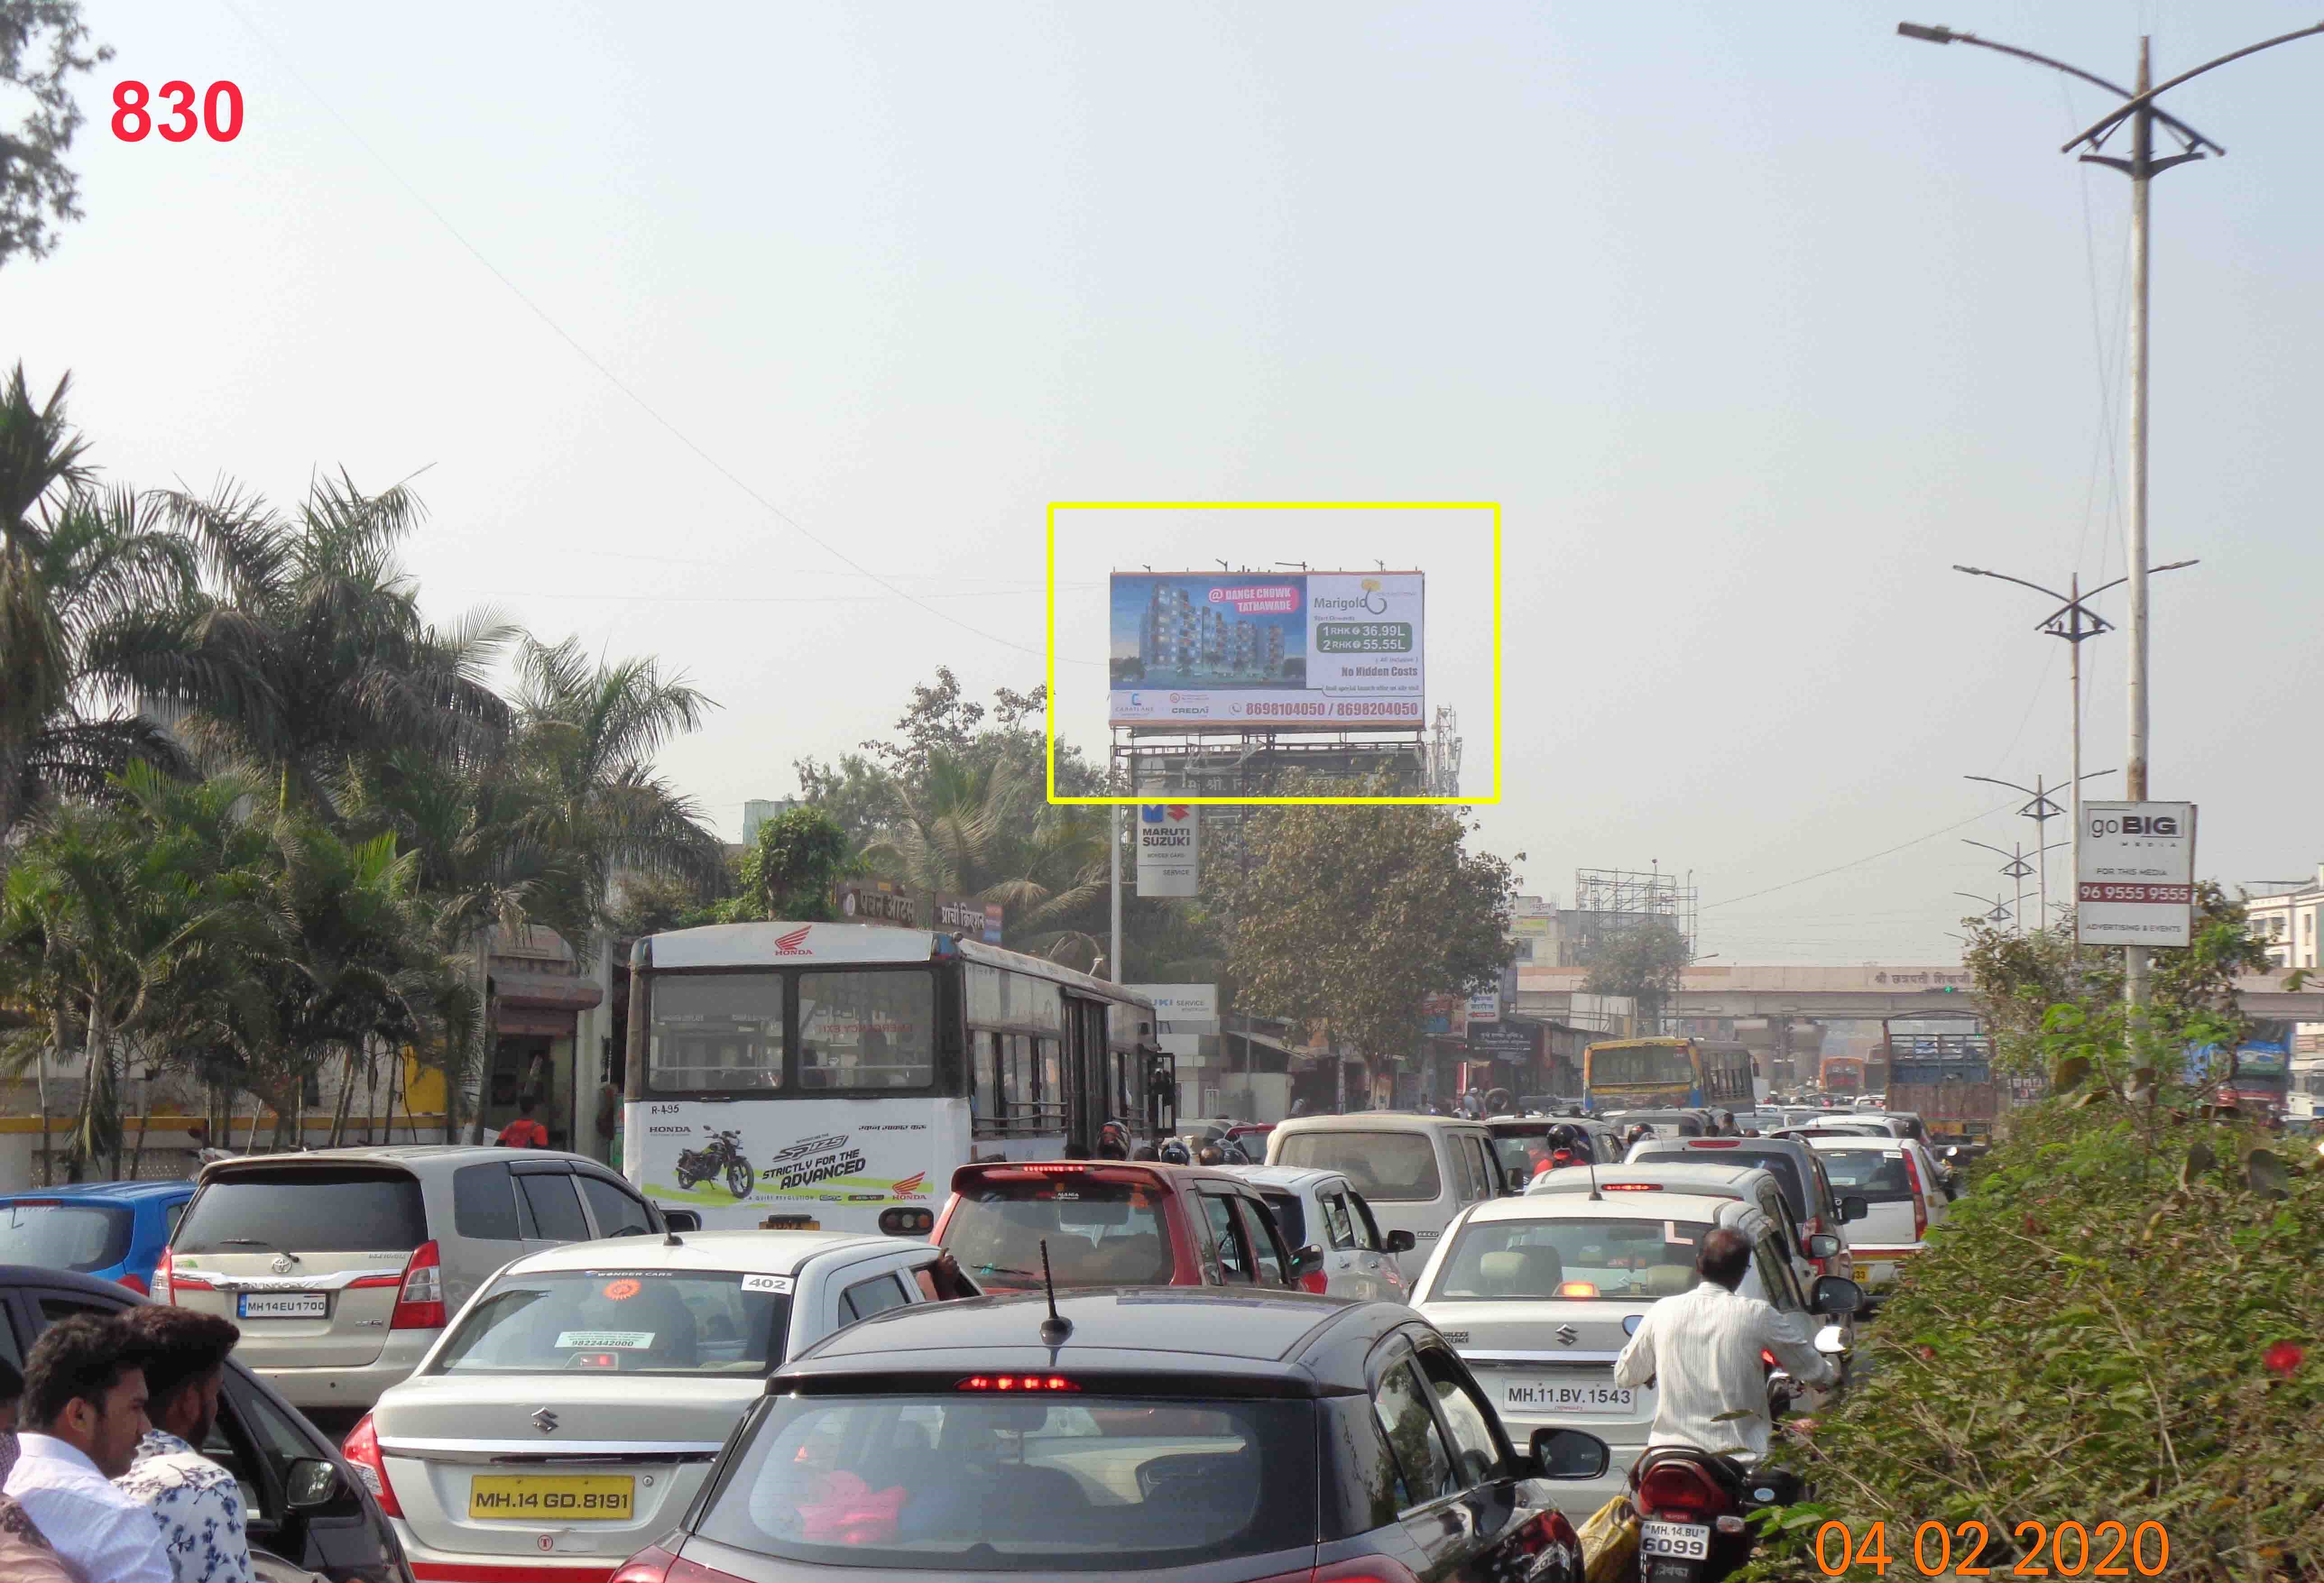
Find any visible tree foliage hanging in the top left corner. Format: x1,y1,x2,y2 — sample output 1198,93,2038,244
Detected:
0,0,114,265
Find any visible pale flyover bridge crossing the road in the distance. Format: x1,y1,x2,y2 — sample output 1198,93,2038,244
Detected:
1517,962,2324,1023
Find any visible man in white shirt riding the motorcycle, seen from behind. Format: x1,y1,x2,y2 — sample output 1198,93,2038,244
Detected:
1613,1225,1838,1462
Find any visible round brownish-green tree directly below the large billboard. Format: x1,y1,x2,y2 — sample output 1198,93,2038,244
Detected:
1211,779,1517,1097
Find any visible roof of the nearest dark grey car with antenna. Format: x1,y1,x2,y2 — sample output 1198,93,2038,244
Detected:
767,1285,1416,1397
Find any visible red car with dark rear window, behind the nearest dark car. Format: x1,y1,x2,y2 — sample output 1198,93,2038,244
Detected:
934,1160,1325,1293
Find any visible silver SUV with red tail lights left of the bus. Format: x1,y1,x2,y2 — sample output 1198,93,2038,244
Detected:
153,1144,692,1411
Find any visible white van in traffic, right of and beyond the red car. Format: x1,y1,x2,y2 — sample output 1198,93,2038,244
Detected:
1267,1111,1508,1290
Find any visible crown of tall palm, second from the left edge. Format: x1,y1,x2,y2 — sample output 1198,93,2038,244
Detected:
91,472,516,825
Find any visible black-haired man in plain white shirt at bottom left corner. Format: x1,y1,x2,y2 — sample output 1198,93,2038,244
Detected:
7,1313,177,1583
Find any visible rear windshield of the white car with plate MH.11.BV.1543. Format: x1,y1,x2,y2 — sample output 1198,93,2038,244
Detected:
1427,1216,1711,1302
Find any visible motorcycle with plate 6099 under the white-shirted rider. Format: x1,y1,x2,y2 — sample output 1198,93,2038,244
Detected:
1632,1325,1848,1583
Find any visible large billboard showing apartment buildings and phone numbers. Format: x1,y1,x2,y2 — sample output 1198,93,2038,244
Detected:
1106,572,1427,730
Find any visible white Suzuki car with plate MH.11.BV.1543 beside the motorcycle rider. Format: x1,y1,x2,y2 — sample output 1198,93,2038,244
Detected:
1413,1172,1854,1523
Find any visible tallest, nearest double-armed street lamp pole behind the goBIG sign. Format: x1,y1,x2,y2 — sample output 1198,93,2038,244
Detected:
1896,21,2324,1013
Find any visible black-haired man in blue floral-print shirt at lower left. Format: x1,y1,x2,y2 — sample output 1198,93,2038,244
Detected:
114,1304,251,1583
